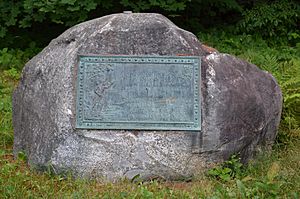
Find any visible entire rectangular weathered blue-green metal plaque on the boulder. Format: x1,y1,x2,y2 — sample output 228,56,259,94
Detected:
76,55,201,130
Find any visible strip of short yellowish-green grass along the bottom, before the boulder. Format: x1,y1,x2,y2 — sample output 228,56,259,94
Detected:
0,135,300,198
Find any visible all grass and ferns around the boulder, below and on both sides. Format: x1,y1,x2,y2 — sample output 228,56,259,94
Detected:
0,32,300,198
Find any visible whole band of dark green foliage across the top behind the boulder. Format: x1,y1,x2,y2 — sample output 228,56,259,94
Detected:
0,0,300,48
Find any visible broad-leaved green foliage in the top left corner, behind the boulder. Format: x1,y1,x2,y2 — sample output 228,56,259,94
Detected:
0,0,106,37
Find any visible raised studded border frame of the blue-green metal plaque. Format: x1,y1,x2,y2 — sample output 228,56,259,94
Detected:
75,54,202,131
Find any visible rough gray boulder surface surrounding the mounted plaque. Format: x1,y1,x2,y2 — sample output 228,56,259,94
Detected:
13,14,282,180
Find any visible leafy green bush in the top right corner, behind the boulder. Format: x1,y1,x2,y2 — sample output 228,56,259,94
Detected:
239,0,300,44
